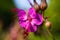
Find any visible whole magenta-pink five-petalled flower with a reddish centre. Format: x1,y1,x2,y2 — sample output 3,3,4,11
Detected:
18,8,43,32
